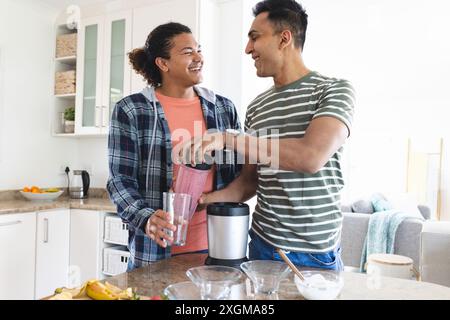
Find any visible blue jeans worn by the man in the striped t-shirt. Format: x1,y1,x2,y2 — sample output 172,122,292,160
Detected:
248,230,344,271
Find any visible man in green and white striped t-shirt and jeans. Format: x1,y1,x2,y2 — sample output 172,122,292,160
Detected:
183,0,354,270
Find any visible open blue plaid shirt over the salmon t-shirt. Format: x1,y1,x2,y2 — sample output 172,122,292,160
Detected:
107,87,241,267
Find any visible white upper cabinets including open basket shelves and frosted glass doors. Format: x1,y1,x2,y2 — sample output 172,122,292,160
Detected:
52,0,218,137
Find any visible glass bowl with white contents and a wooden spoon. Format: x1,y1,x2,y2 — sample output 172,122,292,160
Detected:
294,270,344,300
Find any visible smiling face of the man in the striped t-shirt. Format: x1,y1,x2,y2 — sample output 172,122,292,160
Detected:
245,12,282,77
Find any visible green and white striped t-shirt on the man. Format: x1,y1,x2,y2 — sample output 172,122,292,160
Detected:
245,72,354,253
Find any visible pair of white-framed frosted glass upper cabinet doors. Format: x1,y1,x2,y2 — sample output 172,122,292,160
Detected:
75,10,131,135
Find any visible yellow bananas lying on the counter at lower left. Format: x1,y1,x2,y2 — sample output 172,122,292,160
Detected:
50,280,139,300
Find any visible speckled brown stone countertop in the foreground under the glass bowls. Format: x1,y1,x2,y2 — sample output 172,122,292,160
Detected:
106,254,450,300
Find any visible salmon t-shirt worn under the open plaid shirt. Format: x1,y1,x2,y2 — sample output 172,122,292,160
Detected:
156,92,214,254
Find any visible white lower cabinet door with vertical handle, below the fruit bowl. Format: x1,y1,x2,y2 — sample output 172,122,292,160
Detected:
35,209,70,299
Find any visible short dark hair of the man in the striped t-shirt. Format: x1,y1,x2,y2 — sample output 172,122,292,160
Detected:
253,0,308,50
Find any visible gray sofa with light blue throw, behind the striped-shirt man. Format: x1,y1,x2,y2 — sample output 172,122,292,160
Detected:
341,205,430,270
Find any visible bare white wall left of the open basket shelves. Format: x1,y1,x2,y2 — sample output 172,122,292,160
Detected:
0,0,77,190
